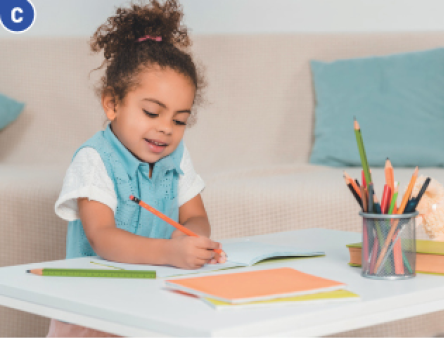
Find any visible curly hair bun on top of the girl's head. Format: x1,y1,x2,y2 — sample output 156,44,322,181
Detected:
90,0,191,61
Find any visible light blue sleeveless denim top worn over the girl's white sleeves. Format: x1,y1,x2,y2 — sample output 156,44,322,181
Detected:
66,124,184,259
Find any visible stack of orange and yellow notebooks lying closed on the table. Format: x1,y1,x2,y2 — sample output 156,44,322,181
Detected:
165,267,360,310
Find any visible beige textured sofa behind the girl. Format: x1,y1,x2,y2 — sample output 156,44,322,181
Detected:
0,33,444,336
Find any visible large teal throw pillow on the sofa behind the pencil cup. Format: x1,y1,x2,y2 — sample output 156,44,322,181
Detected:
310,48,444,167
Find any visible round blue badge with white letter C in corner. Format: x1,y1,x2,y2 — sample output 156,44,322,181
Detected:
0,0,37,33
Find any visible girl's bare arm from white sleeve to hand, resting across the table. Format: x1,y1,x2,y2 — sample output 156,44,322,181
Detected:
78,198,220,269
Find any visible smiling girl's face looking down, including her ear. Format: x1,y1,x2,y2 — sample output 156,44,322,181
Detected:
102,67,195,163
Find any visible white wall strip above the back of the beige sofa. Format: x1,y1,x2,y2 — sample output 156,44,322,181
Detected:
0,0,444,37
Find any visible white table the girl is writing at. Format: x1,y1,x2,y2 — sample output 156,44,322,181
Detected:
0,229,444,336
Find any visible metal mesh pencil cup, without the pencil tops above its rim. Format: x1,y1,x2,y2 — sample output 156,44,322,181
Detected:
359,212,418,280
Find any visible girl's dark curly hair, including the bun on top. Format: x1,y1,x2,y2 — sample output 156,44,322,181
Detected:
90,0,205,126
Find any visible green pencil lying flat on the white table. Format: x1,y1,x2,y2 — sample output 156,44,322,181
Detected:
26,268,156,279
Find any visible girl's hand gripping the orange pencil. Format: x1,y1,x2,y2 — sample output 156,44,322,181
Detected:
167,233,221,269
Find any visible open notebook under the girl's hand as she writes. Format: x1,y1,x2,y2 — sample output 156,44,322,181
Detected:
91,239,325,278
